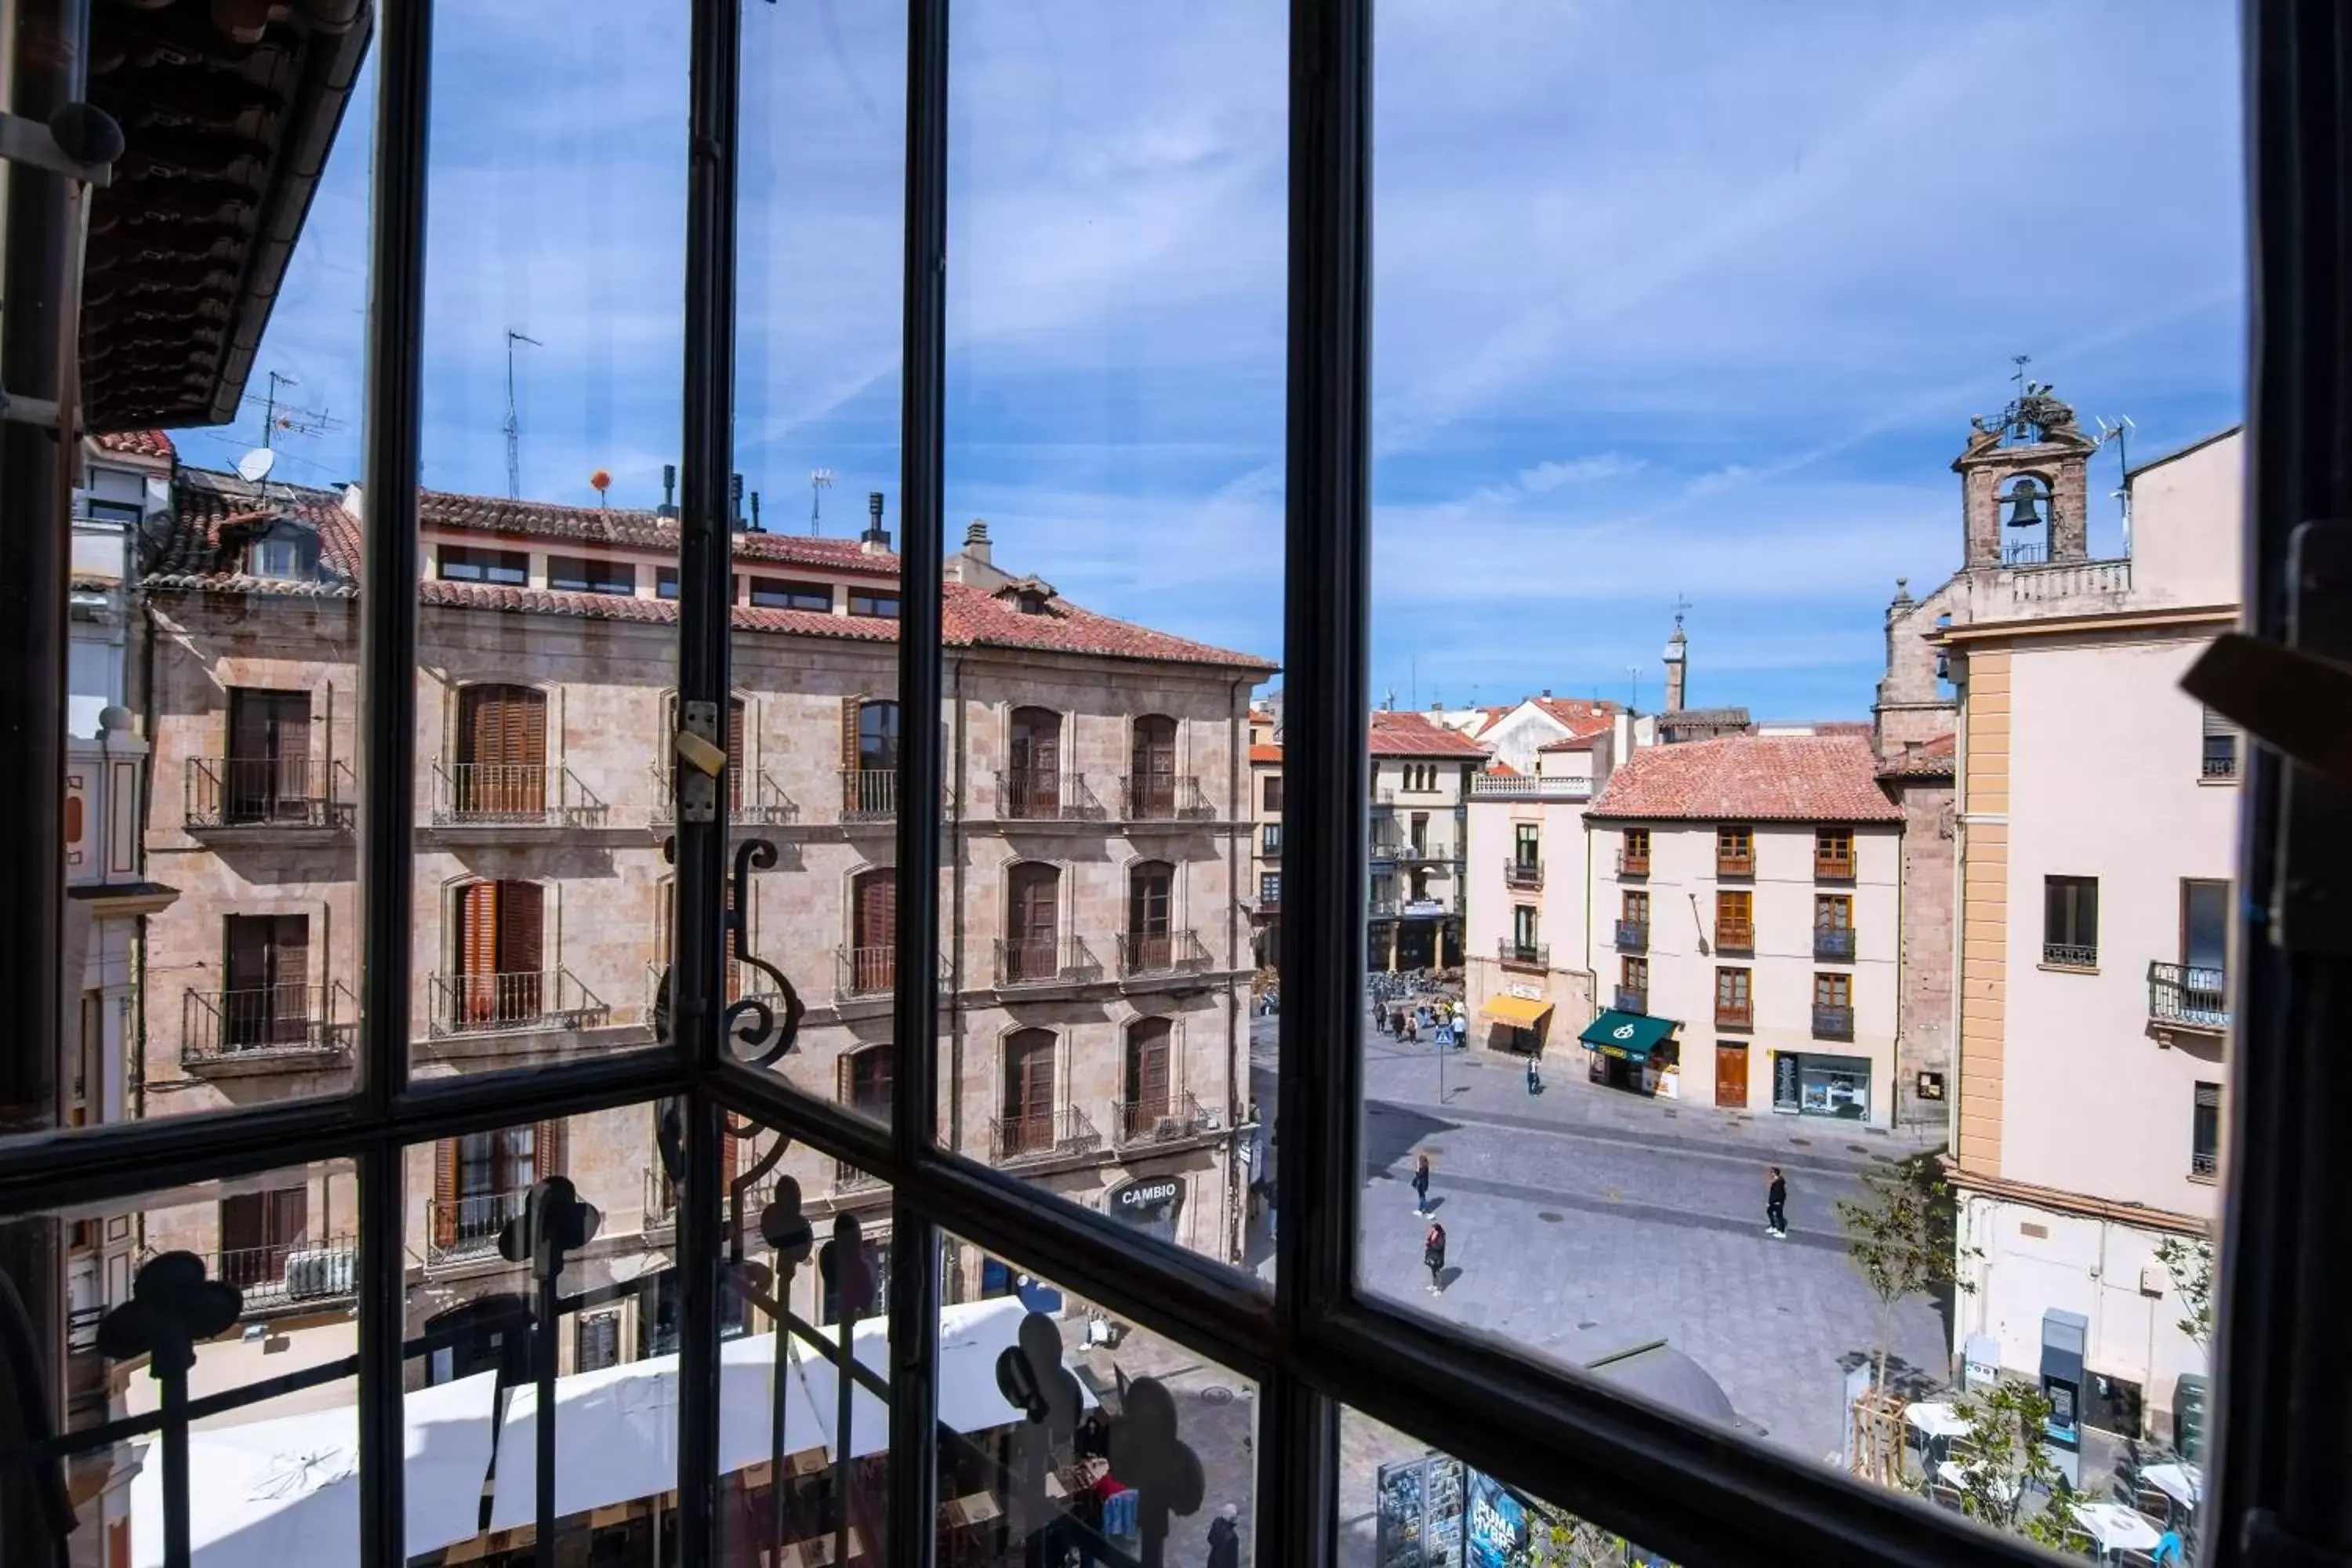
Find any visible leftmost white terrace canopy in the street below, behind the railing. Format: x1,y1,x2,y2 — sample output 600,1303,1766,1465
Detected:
132,1373,496,1568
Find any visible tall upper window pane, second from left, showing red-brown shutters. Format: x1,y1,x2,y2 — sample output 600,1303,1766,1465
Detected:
405,0,687,1079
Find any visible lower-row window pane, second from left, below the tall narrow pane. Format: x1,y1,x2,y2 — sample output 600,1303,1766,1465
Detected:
402,1105,682,1563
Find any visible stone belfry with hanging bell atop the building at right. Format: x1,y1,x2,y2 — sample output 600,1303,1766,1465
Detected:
1952,373,2098,572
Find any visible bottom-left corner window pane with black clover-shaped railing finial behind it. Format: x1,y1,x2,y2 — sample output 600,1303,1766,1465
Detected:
0,1161,362,1563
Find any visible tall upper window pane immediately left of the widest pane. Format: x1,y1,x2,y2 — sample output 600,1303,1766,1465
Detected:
941,0,1287,1265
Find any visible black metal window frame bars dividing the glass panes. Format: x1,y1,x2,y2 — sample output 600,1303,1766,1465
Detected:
0,0,2352,1568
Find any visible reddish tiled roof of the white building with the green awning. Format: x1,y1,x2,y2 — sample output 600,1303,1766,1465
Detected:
1592,736,1903,822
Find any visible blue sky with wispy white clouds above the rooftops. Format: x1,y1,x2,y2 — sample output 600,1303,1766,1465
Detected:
181,0,2244,717
